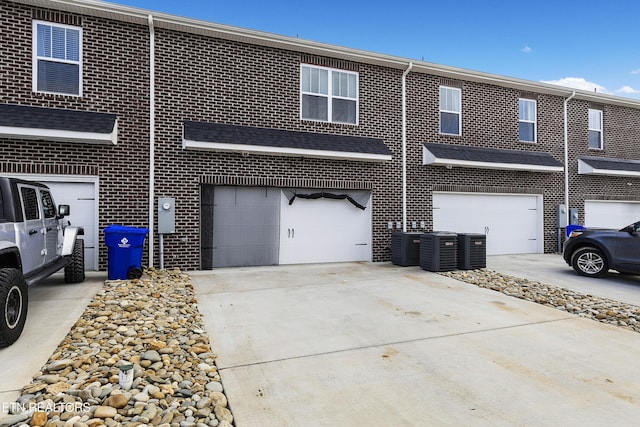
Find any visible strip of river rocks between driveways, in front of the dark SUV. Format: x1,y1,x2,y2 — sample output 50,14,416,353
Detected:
439,269,640,332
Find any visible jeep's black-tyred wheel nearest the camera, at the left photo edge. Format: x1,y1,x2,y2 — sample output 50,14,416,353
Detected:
0,268,29,347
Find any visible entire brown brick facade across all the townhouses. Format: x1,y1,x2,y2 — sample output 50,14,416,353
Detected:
0,0,640,270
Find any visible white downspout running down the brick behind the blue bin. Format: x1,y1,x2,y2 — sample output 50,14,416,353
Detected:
148,15,156,268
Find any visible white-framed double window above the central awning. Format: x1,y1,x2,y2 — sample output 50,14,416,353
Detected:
300,65,358,124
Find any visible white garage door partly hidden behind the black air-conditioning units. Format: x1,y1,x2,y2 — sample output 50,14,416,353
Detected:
433,193,544,255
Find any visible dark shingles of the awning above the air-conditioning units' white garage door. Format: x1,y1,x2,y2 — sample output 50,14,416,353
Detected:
424,142,562,167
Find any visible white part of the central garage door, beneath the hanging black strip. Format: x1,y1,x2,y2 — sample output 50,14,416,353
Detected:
279,193,371,264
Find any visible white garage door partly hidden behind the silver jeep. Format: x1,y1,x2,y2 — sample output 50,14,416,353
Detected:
5,174,98,270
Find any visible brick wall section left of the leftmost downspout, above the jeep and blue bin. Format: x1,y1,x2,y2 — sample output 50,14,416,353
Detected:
0,1,149,268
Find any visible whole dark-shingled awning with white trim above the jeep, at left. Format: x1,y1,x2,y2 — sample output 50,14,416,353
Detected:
0,104,118,145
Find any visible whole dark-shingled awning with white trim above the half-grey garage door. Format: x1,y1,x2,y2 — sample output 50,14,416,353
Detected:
182,121,391,161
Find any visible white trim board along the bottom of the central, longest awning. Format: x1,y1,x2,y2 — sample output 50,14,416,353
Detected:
182,139,391,162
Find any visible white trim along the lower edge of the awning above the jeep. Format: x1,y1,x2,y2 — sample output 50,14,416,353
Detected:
0,119,118,145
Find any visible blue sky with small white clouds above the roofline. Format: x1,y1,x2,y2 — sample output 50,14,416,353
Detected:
107,0,640,99
